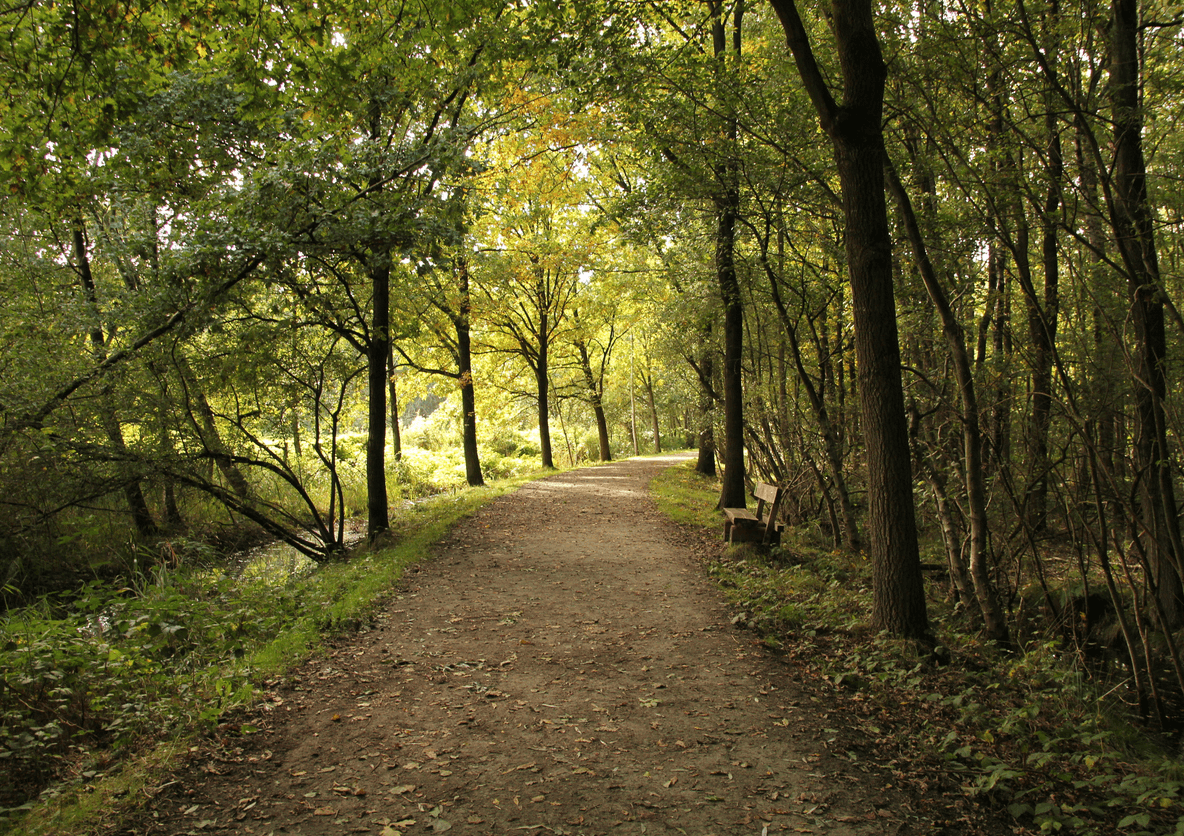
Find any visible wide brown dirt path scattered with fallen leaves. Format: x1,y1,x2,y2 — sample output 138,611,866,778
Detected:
118,456,1012,836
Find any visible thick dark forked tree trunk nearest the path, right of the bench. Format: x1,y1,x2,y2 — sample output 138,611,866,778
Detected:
772,0,929,638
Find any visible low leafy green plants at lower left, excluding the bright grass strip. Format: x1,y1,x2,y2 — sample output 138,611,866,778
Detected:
0,568,261,806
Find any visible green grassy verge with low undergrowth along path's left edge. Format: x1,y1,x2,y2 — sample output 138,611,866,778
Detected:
0,478,537,834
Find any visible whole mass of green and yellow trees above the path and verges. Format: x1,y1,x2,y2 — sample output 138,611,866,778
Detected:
0,0,1184,707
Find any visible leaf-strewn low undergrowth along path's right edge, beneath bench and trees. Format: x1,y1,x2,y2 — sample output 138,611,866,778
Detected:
651,467,1184,836
